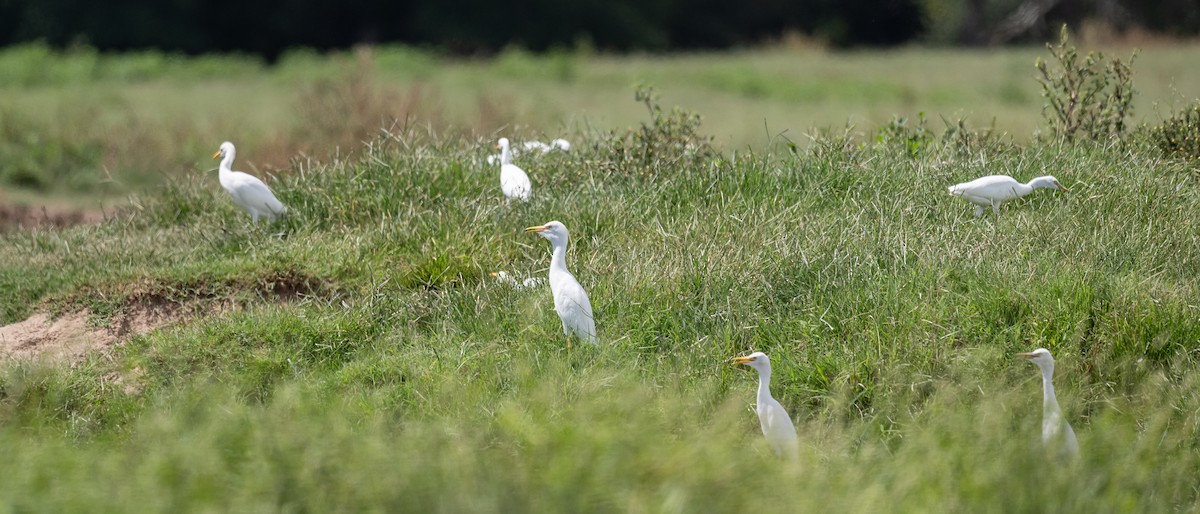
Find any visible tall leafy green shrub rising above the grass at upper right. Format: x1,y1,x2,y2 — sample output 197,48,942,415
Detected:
1036,25,1138,142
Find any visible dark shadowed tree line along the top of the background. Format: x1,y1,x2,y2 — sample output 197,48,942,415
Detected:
0,0,1200,59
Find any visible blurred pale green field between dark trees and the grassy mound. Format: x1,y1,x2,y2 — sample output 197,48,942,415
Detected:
0,39,1200,200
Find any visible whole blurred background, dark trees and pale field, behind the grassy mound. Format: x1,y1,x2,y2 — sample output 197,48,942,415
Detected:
0,0,1200,225
